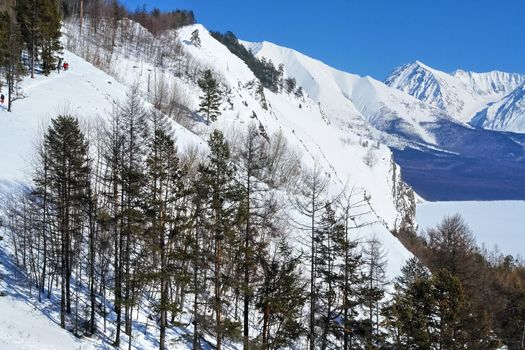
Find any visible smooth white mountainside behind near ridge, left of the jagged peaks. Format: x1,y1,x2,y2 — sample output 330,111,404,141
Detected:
244,42,451,144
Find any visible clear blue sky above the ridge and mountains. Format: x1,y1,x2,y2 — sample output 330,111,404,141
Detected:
119,0,525,79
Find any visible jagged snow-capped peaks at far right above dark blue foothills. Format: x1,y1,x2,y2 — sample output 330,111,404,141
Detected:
385,61,525,132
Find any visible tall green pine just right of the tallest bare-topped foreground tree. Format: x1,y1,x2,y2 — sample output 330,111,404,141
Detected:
145,112,187,350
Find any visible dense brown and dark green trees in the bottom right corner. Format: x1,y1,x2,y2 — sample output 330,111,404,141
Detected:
388,215,525,349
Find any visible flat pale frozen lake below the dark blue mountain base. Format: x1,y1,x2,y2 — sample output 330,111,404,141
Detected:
416,201,525,258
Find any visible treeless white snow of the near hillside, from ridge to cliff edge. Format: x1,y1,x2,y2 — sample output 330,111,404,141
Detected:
0,22,414,349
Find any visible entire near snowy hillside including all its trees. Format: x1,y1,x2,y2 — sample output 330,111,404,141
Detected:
0,0,525,350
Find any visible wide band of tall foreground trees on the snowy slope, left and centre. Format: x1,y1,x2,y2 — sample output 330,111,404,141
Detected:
3,83,422,349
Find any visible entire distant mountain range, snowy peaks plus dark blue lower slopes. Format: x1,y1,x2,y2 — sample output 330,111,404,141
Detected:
244,42,525,200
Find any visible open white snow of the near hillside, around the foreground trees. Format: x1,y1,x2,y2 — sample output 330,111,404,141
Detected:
0,20,413,349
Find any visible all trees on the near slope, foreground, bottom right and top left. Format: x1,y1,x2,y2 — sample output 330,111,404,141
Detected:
1,0,525,349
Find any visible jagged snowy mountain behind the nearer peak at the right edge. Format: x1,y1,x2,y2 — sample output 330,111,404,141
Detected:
385,61,525,123
